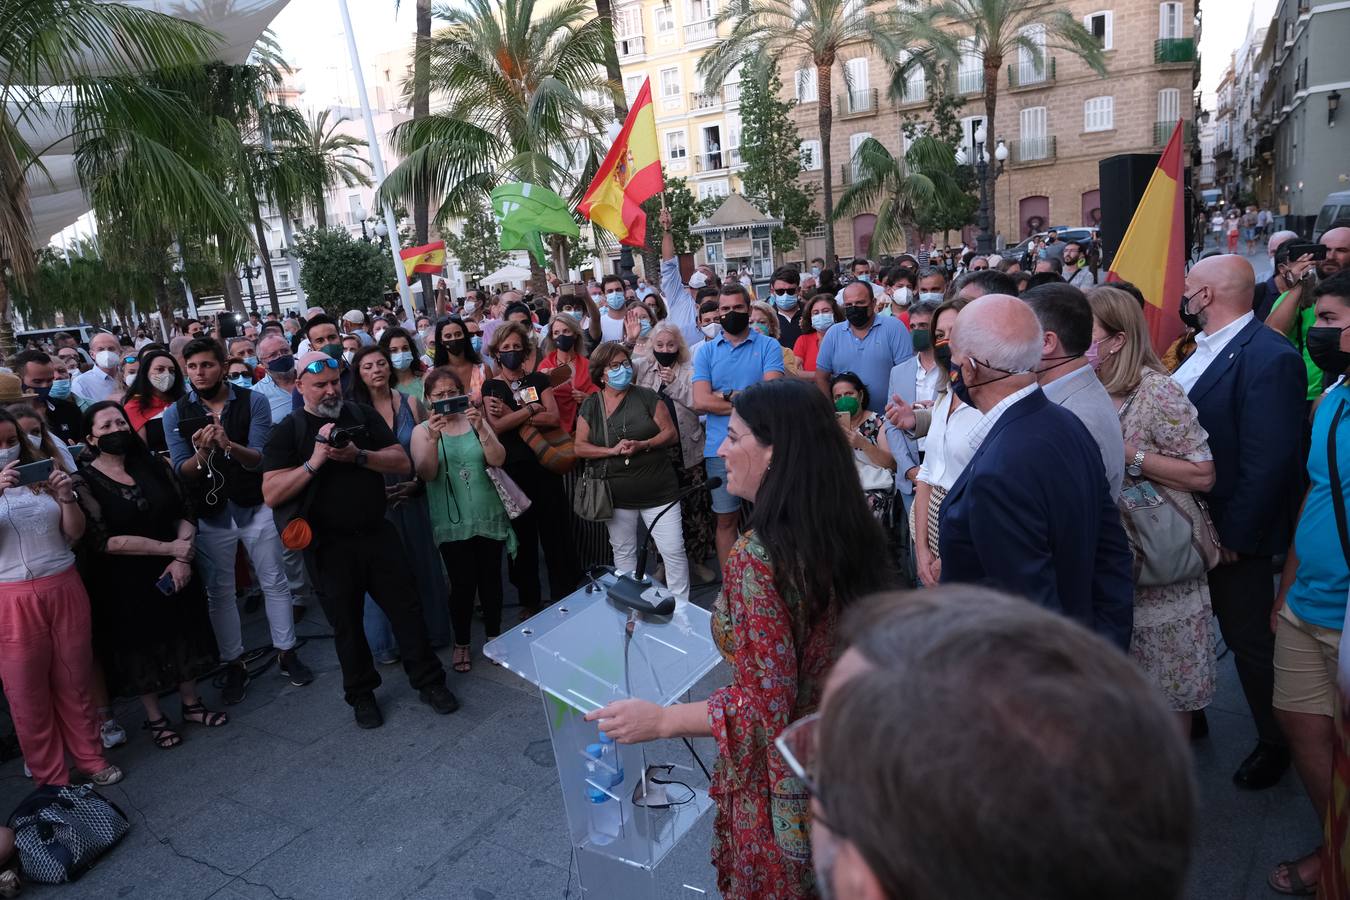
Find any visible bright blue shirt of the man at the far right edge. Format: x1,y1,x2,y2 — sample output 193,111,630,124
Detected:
1285,383,1350,631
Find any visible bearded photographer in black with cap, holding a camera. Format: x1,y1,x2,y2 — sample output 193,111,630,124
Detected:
262,351,459,729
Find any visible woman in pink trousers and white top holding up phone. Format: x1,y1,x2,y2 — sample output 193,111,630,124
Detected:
0,410,122,787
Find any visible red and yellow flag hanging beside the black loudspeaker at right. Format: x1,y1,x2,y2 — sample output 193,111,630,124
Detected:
1107,121,1187,355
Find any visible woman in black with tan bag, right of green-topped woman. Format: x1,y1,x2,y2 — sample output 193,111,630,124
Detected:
483,322,581,619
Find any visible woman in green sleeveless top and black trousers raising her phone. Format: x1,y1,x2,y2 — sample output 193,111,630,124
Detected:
412,368,516,672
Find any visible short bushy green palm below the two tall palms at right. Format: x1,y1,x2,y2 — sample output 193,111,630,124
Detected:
834,135,963,256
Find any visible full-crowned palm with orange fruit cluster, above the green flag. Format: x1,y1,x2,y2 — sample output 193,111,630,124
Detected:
377,0,618,284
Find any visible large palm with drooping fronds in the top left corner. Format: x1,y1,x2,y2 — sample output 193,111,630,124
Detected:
0,0,230,352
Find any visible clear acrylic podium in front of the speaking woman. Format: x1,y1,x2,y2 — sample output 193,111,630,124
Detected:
483,576,721,900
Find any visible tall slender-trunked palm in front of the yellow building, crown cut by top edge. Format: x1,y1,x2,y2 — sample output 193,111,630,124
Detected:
698,0,903,260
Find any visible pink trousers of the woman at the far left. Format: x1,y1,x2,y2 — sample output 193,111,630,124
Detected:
0,565,108,784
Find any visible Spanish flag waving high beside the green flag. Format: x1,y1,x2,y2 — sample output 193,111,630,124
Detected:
576,78,666,247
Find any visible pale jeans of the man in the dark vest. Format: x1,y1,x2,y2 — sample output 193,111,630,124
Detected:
196,506,296,661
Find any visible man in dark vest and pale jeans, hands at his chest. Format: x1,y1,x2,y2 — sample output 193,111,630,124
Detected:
163,337,315,706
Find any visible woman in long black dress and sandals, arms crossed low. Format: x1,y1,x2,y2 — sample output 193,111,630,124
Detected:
80,401,230,750
